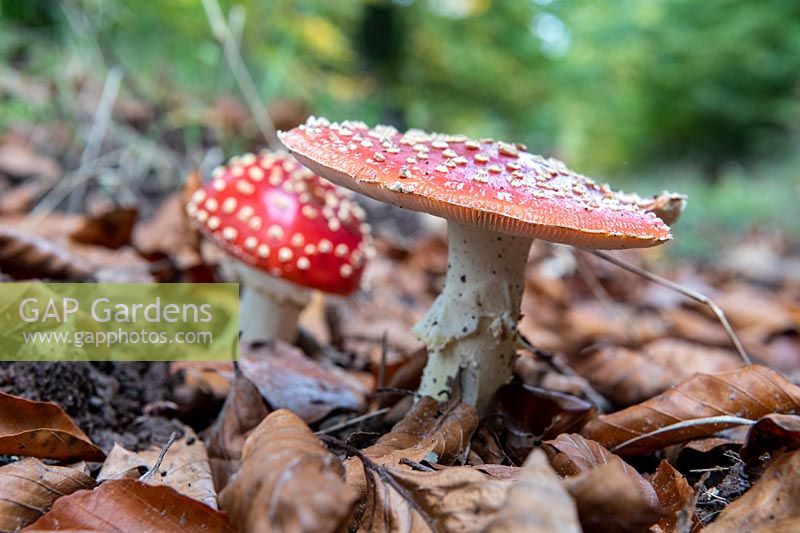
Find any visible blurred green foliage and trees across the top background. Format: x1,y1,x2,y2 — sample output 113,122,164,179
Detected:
0,0,800,254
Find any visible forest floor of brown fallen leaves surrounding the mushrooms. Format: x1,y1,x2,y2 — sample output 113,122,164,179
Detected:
0,72,800,531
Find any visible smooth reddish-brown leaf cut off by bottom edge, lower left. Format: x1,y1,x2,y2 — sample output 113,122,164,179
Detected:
23,479,229,533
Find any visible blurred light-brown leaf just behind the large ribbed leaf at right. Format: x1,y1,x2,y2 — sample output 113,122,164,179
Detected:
572,339,741,406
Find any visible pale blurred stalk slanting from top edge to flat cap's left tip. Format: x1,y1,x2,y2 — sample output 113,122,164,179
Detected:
202,0,281,149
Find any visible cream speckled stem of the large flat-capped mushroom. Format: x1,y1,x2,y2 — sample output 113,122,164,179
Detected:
414,222,533,411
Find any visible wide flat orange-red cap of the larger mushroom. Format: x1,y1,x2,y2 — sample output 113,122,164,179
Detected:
279,117,672,249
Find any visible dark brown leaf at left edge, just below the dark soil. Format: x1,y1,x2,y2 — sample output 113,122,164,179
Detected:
0,392,105,461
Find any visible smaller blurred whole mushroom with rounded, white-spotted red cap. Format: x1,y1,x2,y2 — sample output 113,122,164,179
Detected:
186,152,369,343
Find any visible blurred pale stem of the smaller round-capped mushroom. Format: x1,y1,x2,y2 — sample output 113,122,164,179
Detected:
235,263,311,343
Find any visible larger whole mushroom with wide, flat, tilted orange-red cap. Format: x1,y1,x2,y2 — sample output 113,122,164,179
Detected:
279,117,671,410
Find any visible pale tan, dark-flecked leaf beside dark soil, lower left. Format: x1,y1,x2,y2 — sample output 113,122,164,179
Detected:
97,426,217,509
